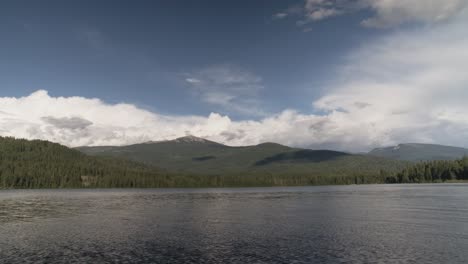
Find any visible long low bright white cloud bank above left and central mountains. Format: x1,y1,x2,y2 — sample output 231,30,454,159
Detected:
0,90,327,147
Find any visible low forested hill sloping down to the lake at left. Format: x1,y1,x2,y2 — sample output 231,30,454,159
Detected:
0,137,170,189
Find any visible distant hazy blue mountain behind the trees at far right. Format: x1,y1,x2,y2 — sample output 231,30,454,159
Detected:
369,143,468,161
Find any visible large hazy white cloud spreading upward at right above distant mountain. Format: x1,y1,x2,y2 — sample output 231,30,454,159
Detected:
314,15,468,151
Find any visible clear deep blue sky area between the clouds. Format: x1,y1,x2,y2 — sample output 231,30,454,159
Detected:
0,1,379,119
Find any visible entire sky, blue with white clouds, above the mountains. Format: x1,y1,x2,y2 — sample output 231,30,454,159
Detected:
0,0,468,152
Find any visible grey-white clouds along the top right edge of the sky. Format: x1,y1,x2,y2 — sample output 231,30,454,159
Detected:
274,0,468,27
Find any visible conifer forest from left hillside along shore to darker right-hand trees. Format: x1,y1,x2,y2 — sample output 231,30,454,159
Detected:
0,137,400,188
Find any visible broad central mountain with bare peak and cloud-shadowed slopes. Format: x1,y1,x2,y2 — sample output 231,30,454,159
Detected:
78,136,406,180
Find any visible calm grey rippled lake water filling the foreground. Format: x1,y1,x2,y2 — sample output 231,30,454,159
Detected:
0,184,468,263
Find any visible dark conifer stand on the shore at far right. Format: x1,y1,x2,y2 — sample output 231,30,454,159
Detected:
386,157,468,183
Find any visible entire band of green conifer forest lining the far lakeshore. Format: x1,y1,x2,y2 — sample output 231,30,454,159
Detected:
0,137,468,189
